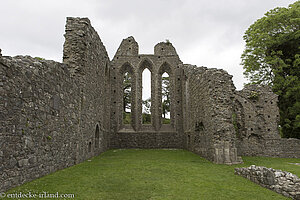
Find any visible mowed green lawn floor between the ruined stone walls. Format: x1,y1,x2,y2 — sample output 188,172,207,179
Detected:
7,149,300,200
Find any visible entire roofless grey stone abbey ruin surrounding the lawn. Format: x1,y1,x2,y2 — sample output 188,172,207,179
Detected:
0,18,300,191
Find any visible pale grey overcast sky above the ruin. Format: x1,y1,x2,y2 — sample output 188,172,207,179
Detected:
0,0,296,89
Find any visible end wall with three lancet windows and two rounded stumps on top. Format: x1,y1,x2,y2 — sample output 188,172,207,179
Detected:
110,37,184,148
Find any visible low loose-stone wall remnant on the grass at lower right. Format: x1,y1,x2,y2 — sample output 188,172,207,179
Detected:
235,165,300,199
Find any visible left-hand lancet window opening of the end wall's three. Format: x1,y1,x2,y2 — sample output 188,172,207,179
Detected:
123,72,132,124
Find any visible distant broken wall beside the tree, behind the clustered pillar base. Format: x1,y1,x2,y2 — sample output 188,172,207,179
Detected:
233,85,300,158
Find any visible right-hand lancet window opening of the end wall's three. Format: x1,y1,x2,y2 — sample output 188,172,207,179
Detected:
161,72,171,124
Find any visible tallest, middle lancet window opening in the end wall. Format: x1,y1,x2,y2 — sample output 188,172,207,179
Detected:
142,68,151,124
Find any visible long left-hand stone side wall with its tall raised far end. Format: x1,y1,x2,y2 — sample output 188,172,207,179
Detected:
0,18,109,191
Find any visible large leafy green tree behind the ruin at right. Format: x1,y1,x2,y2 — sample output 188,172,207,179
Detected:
242,1,300,138
